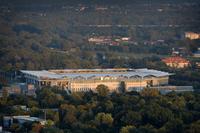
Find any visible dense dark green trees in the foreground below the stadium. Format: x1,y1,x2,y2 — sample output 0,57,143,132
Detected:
0,87,200,133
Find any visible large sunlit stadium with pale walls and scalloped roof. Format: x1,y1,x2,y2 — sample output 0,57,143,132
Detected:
21,69,171,92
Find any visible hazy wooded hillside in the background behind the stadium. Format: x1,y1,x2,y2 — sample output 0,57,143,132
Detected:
0,0,200,71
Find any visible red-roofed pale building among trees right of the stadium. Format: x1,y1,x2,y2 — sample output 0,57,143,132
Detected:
162,56,190,68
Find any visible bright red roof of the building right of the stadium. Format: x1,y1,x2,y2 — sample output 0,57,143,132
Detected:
162,56,189,63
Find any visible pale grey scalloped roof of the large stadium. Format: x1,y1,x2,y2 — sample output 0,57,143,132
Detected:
21,68,171,79
